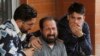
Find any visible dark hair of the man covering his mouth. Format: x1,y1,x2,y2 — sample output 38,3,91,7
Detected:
68,2,85,15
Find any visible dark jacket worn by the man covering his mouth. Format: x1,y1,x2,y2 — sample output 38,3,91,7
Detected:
57,16,92,56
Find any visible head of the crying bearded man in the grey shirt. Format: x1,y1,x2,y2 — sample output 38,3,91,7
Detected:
39,17,58,44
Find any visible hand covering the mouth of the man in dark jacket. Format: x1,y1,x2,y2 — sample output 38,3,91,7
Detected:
69,23,83,37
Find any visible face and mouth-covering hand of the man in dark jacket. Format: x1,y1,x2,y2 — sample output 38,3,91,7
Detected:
68,12,85,37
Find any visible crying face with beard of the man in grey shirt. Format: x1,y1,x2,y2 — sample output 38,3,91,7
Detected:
41,20,58,44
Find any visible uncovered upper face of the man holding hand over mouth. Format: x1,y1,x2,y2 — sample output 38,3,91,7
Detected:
68,12,85,27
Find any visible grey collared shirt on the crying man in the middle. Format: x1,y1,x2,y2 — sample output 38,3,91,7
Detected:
33,38,67,56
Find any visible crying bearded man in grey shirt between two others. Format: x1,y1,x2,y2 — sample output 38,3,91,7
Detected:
34,17,67,56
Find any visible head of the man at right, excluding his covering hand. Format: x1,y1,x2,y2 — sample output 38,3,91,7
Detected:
68,2,85,26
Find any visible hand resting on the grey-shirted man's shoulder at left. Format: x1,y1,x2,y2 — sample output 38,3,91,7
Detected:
28,36,42,49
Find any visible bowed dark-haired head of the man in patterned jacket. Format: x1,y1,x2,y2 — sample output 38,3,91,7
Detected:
14,4,37,33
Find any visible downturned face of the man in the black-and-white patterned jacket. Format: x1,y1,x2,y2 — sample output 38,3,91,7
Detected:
20,18,36,33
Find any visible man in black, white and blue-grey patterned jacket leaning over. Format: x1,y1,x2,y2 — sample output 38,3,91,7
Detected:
0,4,37,56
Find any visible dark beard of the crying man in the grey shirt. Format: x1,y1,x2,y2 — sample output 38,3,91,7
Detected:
42,34,58,44
